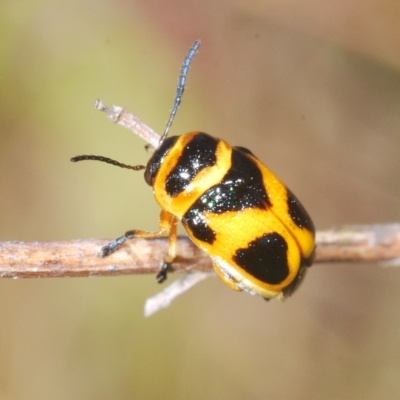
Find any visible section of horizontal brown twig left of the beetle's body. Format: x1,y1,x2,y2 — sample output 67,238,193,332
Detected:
0,238,211,279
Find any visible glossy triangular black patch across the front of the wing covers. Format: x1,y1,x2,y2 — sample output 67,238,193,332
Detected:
193,149,272,214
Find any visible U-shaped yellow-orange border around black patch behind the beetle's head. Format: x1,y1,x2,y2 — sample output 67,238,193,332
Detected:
154,132,232,218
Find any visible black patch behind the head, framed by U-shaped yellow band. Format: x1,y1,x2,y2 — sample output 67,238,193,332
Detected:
165,132,219,197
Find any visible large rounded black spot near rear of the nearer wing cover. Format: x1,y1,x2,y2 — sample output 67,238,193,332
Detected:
233,232,289,285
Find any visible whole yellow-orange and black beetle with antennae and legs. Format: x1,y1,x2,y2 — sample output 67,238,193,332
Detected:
71,41,315,300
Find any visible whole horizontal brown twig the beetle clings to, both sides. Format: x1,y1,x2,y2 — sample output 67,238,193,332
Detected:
0,224,400,278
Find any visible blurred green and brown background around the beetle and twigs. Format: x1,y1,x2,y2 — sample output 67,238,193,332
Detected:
0,0,400,400
